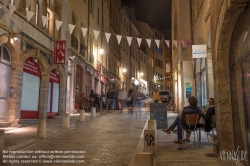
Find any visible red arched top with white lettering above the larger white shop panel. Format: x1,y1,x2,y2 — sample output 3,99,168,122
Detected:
23,57,41,77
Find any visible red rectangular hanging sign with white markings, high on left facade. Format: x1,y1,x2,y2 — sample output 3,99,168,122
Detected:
54,40,66,64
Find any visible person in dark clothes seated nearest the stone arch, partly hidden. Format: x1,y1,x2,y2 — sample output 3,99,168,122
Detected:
199,98,215,132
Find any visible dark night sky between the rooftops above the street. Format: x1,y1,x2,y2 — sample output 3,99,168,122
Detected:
122,0,171,30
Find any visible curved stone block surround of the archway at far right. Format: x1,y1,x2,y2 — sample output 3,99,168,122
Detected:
212,0,247,150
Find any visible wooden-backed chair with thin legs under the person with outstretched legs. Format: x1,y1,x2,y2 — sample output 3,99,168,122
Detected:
182,114,201,148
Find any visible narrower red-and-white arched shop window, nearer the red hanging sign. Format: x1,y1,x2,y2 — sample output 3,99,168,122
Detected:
47,70,60,118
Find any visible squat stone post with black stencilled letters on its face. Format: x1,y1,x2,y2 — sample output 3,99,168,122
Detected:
144,130,156,156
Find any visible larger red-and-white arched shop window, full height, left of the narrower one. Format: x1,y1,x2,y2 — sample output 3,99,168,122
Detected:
21,57,41,119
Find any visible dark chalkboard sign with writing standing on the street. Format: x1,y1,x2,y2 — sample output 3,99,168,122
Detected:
150,103,168,129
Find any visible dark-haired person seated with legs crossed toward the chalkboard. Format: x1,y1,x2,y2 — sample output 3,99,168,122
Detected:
162,96,202,144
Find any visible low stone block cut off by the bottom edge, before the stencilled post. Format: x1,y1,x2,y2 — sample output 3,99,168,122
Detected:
135,152,153,166
